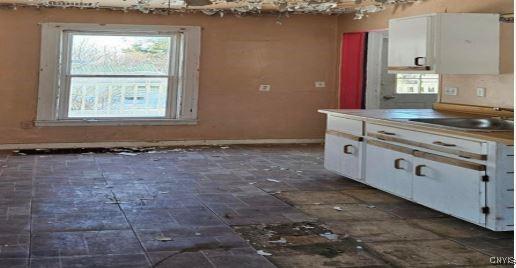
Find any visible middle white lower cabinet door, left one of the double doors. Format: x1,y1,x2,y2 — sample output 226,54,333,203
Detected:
365,143,413,199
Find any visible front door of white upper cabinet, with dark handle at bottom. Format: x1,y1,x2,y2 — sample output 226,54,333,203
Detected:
388,17,433,67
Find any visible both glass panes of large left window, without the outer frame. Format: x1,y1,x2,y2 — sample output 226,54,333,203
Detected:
64,32,176,118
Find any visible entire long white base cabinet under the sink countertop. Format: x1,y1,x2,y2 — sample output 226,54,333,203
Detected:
318,113,514,231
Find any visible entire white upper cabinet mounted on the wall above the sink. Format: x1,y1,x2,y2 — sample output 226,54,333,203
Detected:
388,13,500,74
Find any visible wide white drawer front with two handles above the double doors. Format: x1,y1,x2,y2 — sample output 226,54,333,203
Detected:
366,124,487,160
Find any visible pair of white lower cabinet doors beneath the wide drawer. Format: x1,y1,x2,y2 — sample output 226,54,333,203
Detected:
365,140,487,226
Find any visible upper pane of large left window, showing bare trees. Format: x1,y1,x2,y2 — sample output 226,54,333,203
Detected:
70,34,171,75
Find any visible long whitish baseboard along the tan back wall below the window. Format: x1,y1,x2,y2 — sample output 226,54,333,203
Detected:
0,139,324,150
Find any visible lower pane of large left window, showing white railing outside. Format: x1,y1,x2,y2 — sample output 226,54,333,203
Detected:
68,77,168,118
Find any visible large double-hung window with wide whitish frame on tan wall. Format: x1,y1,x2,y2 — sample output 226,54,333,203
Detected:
36,23,200,126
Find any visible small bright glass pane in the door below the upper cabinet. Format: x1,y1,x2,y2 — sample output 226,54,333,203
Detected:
396,74,439,94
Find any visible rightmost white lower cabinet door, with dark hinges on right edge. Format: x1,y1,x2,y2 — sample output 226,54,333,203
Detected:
413,157,485,224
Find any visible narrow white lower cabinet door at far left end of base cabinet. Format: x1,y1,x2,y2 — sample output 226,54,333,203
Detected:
324,134,364,180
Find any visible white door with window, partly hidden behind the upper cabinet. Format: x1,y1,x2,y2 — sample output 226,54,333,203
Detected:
365,31,439,109
